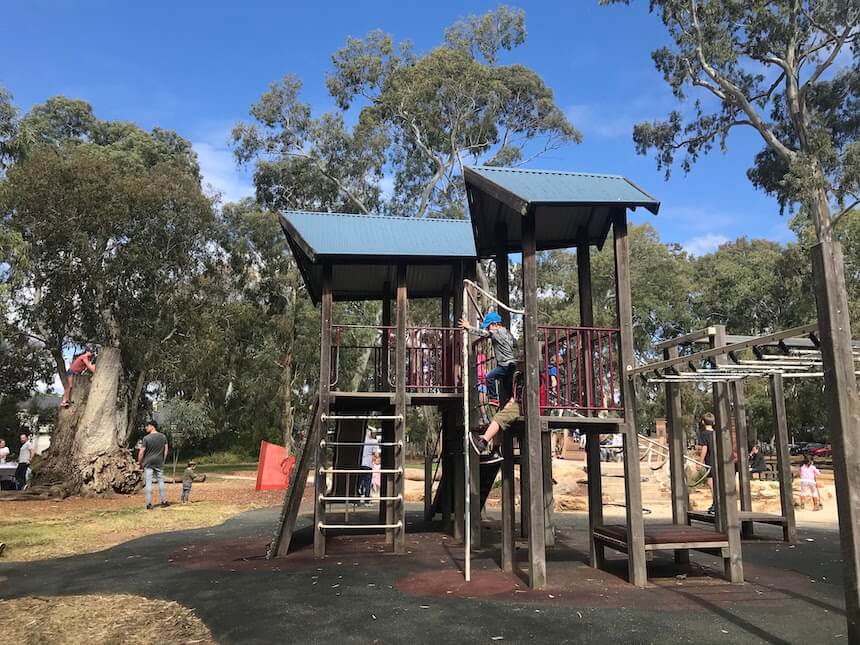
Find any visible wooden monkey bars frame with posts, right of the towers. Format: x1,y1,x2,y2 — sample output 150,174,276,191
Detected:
634,323,860,543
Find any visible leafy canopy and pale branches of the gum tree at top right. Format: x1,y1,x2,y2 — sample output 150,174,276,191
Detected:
602,0,860,234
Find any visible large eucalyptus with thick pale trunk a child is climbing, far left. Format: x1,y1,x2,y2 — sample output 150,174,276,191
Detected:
0,97,212,493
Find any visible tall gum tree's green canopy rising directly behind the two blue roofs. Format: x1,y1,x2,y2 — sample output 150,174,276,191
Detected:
233,6,580,217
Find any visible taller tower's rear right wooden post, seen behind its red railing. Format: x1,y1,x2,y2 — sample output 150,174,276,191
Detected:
576,244,605,568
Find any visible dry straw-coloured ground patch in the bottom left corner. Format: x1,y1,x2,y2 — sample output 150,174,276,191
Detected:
0,594,216,645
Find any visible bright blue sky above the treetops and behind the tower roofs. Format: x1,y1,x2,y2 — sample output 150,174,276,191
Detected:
0,0,816,253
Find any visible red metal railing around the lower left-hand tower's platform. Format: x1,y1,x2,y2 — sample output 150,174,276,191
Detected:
331,325,463,393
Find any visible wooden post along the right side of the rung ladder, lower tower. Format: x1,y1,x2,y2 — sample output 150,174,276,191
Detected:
393,264,407,553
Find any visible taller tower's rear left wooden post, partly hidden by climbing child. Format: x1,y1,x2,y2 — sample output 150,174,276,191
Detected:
496,221,516,571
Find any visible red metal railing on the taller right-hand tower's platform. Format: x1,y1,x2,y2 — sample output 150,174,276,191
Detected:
538,325,624,412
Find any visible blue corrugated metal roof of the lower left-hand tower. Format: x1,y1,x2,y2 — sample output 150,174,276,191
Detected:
284,211,475,258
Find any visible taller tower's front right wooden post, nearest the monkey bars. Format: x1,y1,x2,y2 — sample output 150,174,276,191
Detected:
612,208,648,587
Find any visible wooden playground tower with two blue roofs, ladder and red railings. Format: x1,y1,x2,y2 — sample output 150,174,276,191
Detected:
270,167,743,588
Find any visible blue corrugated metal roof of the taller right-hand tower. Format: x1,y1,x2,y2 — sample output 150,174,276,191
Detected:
469,166,660,213
